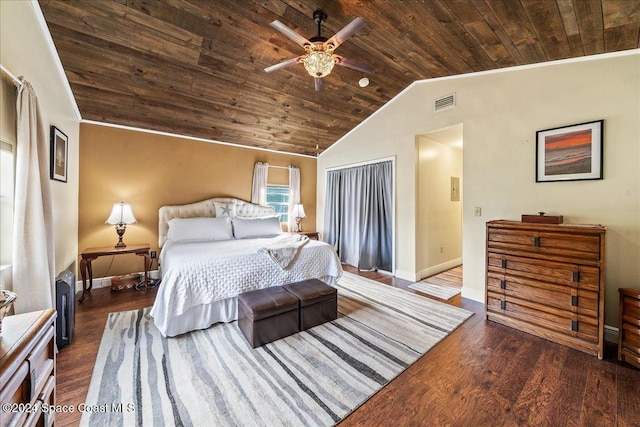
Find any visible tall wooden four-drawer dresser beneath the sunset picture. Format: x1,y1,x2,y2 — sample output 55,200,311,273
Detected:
485,220,606,359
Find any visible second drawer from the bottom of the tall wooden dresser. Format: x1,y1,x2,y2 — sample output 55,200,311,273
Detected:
487,272,598,318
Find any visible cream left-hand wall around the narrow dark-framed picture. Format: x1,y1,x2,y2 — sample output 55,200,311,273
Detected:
0,0,80,274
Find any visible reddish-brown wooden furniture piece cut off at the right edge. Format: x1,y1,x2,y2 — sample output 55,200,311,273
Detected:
618,288,640,368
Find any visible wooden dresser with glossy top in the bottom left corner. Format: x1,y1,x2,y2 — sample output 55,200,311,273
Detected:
0,310,56,427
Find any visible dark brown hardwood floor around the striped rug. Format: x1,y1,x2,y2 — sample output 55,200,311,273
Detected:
57,266,640,427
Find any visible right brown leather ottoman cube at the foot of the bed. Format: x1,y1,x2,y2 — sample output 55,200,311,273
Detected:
283,279,338,331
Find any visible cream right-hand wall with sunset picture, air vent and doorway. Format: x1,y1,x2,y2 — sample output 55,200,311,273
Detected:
317,50,640,325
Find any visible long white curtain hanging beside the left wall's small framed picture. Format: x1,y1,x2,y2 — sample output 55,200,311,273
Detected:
12,81,55,313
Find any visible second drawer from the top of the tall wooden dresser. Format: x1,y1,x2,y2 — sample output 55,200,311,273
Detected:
487,253,600,292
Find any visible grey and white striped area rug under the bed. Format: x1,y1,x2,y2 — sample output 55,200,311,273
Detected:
81,272,472,426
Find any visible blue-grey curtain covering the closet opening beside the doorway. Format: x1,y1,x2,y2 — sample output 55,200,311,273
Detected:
324,161,393,271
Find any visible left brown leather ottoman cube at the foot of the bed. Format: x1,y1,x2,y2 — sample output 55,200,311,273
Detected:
238,286,300,348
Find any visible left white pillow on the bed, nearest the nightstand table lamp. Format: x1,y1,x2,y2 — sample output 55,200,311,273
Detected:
167,217,233,242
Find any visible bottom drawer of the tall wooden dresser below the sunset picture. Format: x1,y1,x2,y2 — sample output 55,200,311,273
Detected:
487,292,599,343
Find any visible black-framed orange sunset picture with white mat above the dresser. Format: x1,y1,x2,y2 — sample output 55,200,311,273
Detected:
536,120,604,182
